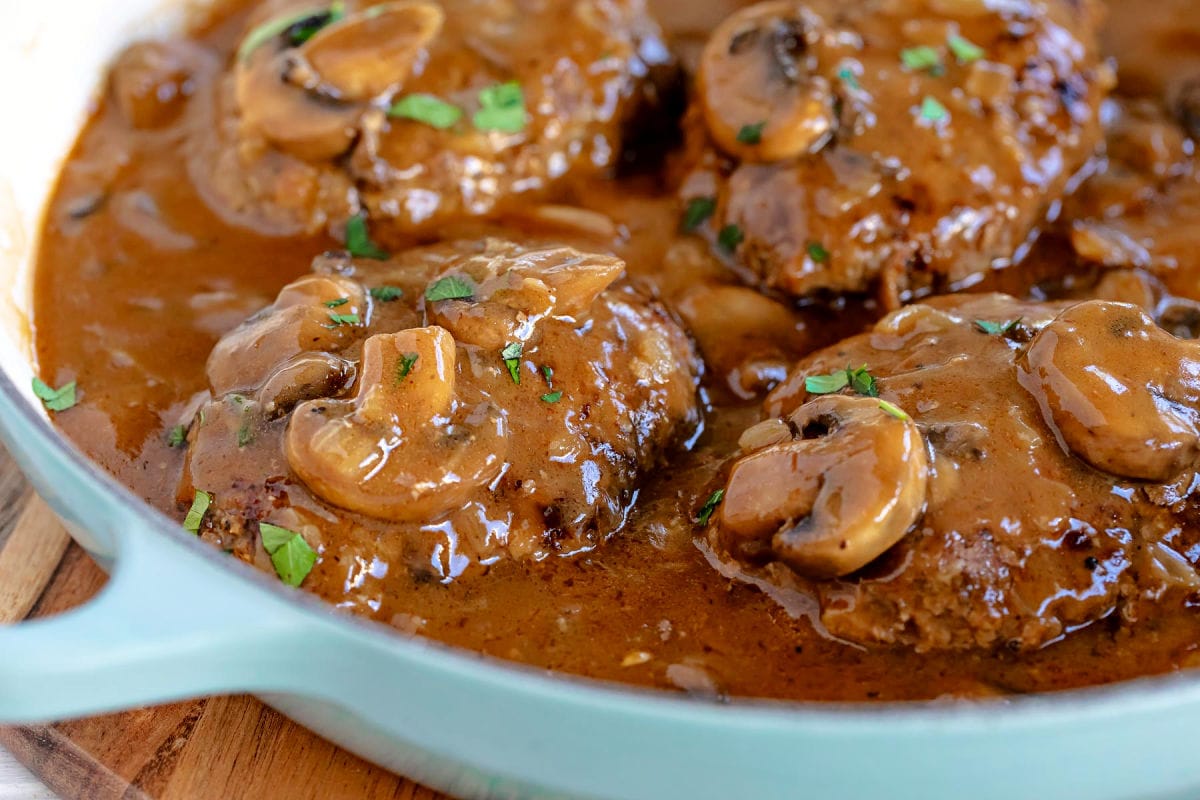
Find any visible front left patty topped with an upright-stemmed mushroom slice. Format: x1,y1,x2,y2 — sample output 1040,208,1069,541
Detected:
181,240,700,578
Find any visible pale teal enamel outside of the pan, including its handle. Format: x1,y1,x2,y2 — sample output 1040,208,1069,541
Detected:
0,371,1200,800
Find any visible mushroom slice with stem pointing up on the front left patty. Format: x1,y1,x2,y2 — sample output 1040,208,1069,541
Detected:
284,326,508,522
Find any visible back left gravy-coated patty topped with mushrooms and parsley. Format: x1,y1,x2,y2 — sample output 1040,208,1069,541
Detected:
186,0,674,236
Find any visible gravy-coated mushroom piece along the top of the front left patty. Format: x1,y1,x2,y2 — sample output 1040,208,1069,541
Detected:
426,242,625,349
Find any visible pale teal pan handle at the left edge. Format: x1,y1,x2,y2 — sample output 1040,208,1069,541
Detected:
0,523,316,723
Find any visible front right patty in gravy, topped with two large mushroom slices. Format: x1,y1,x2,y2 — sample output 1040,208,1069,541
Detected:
709,295,1200,650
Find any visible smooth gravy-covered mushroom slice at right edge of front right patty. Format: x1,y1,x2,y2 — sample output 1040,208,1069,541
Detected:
1020,300,1200,481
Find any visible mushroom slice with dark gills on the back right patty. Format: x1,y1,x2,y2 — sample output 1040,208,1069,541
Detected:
698,0,836,161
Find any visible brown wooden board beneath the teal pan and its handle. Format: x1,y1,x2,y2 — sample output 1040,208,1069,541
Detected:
0,449,445,800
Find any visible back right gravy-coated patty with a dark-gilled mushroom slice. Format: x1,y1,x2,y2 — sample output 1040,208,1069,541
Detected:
683,0,1112,303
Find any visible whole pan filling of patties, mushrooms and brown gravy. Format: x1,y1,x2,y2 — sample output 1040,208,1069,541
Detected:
34,0,1200,700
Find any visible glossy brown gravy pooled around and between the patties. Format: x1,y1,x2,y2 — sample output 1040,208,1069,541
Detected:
34,0,1200,700
